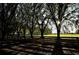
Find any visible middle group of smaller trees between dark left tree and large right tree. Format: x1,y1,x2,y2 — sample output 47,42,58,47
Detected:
16,4,51,38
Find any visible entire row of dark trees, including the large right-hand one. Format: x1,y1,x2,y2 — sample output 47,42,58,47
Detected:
0,3,79,54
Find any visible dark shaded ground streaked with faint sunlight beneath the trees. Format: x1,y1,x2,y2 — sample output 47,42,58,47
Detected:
0,40,79,55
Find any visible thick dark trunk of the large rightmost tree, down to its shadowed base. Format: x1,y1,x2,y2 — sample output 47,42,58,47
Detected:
53,26,63,55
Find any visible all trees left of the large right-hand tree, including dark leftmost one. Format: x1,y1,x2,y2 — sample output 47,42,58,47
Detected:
0,4,51,39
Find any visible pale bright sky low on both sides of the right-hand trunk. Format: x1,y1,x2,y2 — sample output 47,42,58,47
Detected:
48,21,76,33
